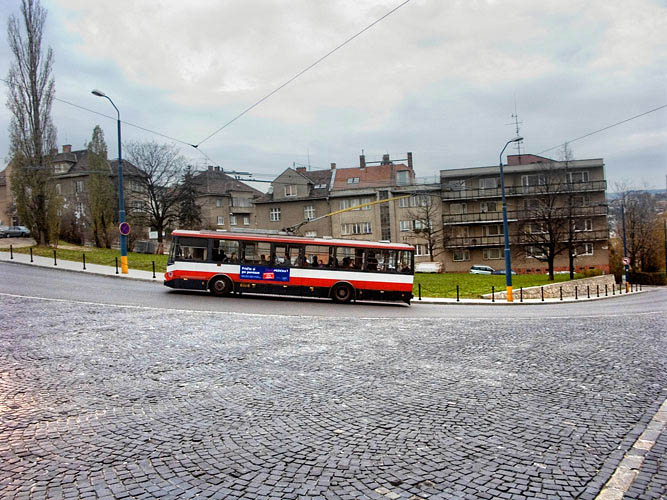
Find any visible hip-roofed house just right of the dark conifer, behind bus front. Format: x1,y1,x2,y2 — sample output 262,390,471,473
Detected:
193,166,262,231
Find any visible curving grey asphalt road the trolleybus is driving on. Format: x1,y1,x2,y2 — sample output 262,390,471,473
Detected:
0,262,667,319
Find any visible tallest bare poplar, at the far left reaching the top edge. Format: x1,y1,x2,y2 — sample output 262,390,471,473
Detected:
7,0,59,244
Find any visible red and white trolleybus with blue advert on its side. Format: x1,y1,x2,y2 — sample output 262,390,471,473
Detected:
164,230,414,304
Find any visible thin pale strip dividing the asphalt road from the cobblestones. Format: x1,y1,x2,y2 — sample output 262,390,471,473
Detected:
0,292,664,321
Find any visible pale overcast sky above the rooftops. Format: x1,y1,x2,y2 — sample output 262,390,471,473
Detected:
0,0,667,189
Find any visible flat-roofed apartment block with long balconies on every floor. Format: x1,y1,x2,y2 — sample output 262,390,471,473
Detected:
440,155,609,273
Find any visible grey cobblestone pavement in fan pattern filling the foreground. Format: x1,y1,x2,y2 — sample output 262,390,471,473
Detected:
0,296,667,500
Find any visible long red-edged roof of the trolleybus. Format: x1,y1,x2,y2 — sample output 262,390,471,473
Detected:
171,229,414,250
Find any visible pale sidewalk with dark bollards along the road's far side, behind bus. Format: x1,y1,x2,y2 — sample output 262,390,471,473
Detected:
0,252,647,306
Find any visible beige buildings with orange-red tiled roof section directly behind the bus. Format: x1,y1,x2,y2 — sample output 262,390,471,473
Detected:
255,153,441,260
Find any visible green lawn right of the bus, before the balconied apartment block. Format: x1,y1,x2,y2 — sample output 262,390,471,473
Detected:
413,273,581,299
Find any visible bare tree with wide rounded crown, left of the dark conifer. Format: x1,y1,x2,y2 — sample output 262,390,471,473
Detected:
126,142,185,252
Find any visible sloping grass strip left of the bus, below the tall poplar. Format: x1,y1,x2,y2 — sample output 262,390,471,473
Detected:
2,242,167,273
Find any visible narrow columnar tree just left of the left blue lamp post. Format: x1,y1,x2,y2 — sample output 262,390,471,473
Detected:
88,125,116,248
